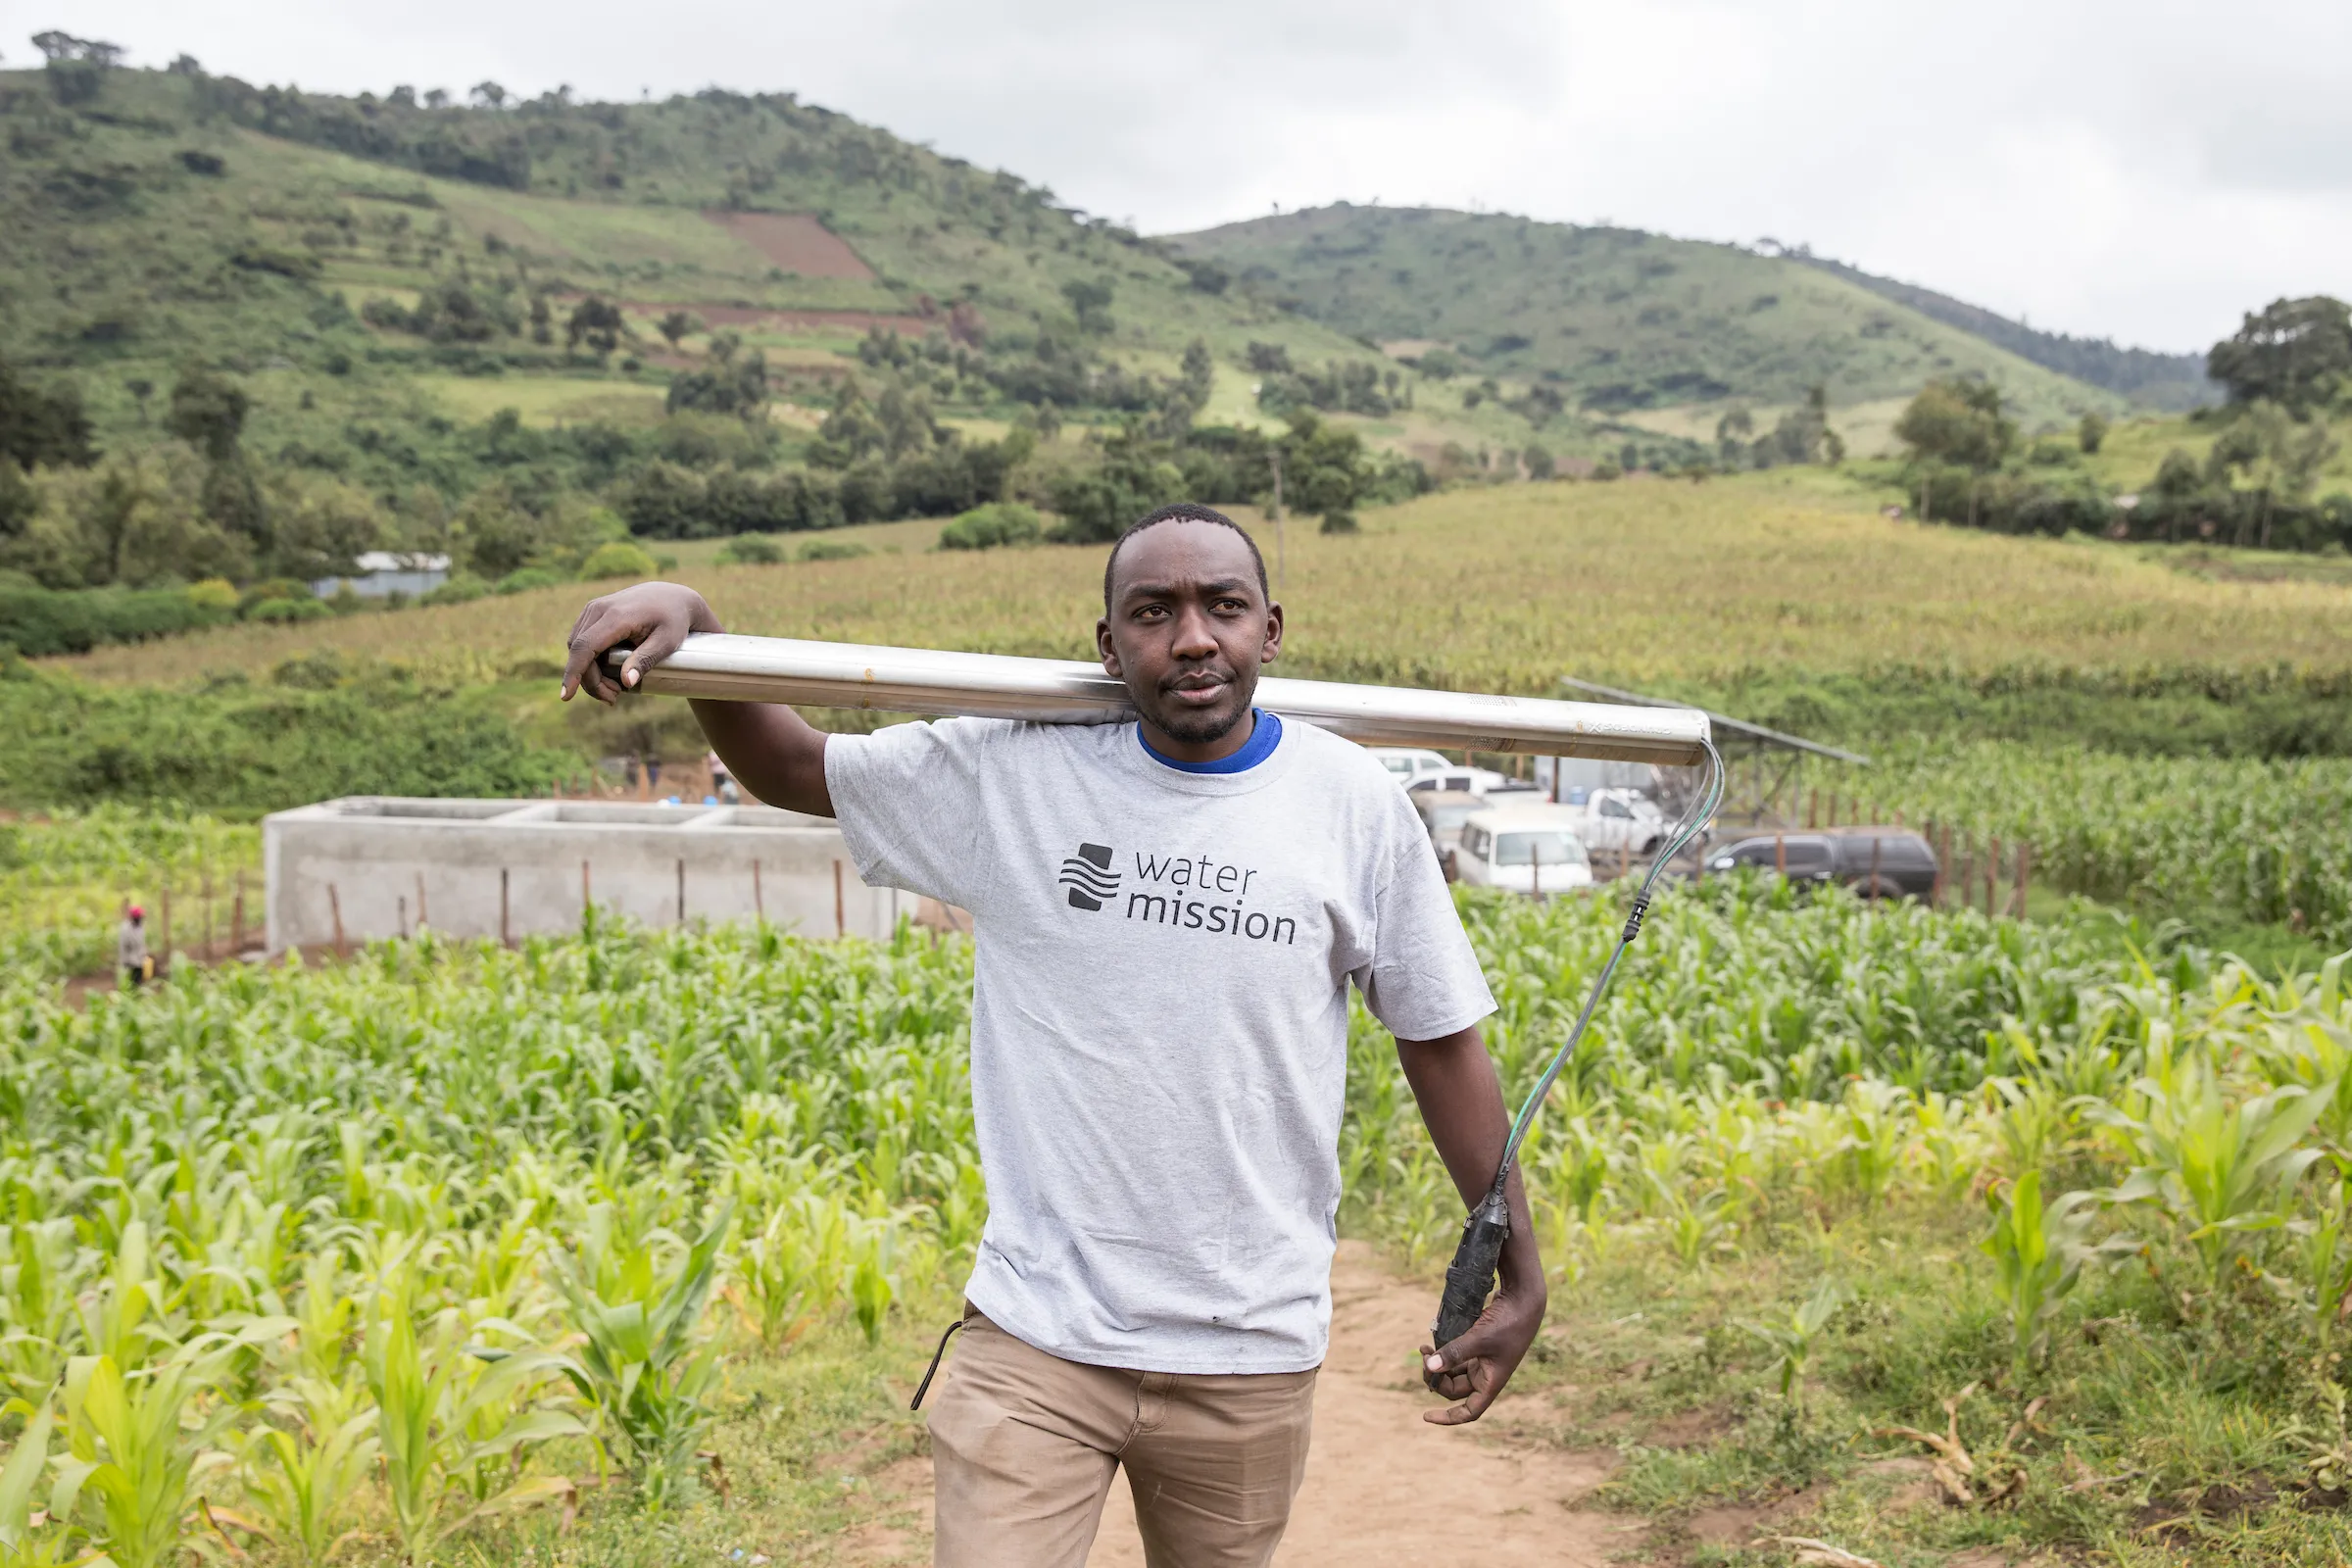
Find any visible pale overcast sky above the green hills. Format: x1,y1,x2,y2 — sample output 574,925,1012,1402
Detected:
31,0,2352,350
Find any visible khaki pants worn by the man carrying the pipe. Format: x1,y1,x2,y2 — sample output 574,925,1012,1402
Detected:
931,1314,1315,1568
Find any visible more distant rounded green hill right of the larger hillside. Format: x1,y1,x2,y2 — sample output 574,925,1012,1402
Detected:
1169,205,2124,428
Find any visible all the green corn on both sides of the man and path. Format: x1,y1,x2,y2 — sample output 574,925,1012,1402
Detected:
0,879,2352,1568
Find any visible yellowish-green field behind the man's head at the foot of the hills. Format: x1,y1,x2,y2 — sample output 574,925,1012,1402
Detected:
57,470,2352,694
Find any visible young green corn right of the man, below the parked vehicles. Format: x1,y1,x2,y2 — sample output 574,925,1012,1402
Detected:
1341,877,2352,1333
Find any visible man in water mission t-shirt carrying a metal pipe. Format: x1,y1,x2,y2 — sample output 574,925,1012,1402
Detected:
564,506,1545,1568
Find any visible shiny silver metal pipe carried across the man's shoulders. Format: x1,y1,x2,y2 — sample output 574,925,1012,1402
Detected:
607,632,1710,766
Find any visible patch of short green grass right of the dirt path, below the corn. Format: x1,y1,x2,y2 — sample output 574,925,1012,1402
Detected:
1512,1201,2352,1568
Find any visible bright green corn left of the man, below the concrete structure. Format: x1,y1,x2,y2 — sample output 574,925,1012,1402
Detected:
0,921,983,1566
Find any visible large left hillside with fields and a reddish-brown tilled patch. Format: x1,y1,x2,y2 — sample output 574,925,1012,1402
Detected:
0,69,1374,465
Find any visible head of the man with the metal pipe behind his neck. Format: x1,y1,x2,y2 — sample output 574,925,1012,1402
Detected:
1094,522,1282,745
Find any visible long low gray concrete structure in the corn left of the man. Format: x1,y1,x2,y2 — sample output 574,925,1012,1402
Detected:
261,797,912,955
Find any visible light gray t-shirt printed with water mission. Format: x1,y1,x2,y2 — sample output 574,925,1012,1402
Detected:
825,719,1494,1373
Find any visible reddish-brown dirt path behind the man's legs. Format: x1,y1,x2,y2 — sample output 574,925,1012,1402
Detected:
842,1242,1642,1568
